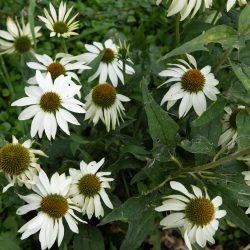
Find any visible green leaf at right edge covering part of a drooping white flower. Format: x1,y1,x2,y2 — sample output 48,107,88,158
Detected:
236,112,250,149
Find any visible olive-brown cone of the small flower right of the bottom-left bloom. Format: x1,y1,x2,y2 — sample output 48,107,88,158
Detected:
78,174,101,197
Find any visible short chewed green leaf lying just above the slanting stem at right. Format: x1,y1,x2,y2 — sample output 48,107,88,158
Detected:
181,136,214,154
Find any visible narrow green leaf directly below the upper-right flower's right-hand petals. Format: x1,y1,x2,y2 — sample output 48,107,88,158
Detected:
192,98,225,127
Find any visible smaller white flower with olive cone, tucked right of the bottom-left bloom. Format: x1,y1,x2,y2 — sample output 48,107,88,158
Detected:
69,158,114,219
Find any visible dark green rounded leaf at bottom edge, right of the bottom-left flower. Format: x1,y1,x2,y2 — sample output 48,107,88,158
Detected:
73,224,105,250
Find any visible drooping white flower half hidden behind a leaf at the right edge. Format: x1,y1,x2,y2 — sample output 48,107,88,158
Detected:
218,106,246,149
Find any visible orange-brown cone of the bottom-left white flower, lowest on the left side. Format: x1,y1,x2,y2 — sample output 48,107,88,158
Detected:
41,194,69,219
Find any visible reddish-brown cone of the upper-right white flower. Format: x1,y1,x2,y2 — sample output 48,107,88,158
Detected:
181,69,205,93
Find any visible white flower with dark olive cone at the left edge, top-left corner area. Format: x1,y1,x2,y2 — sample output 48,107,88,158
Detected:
0,17,41,54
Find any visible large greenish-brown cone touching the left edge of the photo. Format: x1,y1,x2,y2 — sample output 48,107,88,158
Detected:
0,144,30,175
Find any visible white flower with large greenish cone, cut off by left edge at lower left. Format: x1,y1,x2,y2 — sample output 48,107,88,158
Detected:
0,136,46,192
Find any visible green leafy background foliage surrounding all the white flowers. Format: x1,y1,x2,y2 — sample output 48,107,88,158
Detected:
0,0,250,250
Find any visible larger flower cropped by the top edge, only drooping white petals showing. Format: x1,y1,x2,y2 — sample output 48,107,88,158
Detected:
156,0,213,21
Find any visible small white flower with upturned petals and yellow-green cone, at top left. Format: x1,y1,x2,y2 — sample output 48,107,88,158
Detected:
38,1,79,38
